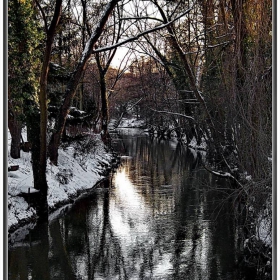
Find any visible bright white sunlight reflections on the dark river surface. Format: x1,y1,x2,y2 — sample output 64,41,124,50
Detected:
110,155,211,279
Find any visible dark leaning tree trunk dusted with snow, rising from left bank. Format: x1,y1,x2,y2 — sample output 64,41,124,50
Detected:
48,0,120,165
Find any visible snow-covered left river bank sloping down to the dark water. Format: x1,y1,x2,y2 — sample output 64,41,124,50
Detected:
7,132,113,232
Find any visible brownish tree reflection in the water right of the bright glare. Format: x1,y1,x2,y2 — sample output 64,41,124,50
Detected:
124,137,201,215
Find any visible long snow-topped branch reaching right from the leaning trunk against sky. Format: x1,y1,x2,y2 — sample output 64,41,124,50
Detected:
92,8,192,53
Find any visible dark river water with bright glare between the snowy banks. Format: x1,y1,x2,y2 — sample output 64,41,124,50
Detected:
8,130,245,280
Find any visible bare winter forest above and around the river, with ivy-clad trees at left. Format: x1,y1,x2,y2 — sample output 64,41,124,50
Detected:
7,0,273,279
